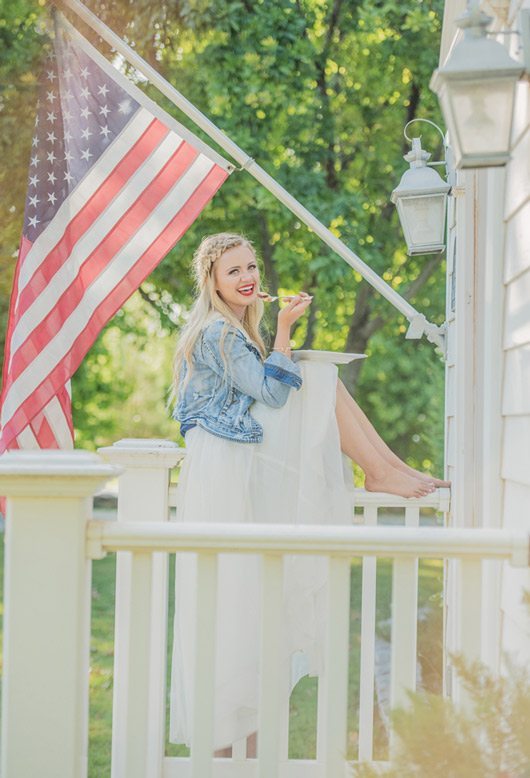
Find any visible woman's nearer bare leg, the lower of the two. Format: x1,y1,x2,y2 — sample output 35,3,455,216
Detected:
335,380,435,497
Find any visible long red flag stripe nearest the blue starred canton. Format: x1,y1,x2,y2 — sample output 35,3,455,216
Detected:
17,119,169,316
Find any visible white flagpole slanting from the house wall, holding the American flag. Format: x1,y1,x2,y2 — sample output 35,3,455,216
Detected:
53,0,445,348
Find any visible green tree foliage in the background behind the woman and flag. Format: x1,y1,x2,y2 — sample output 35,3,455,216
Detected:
0,0,445,469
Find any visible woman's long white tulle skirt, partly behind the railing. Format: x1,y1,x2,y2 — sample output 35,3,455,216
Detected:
169,361,353,749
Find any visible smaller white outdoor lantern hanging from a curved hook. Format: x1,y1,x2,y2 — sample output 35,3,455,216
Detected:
390,138,451,254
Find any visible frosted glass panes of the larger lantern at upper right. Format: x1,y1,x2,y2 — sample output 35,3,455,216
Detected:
448,79,514,155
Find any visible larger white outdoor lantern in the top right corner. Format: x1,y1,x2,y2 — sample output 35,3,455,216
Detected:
431,4,524,168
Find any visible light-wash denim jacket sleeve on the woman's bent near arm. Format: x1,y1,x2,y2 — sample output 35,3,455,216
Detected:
201,321,302,408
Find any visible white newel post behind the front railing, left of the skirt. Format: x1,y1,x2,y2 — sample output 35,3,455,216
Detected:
98,439,185,778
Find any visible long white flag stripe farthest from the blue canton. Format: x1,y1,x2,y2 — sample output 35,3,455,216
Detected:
2,154,214,425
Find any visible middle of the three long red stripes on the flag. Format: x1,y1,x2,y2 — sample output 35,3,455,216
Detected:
4,143,198,386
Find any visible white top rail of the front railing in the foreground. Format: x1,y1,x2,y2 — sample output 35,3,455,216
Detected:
87,520,530,567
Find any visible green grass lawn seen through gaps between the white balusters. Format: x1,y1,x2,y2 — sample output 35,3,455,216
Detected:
0,533,442,778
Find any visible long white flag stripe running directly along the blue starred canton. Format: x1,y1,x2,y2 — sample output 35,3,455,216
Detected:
19,108,153,294
